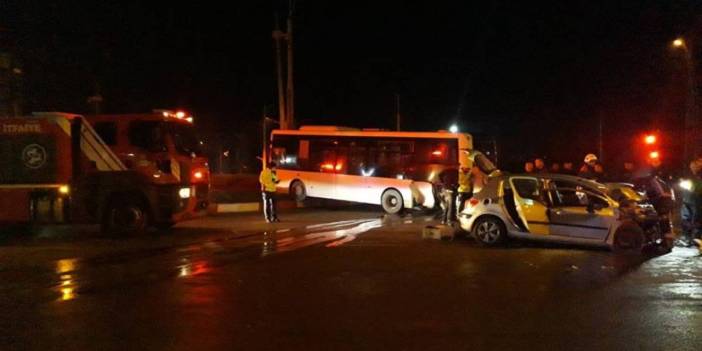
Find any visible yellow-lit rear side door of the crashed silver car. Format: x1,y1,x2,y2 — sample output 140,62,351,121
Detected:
509,176,550,235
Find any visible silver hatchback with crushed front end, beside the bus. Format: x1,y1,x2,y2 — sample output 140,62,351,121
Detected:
458,174,670,252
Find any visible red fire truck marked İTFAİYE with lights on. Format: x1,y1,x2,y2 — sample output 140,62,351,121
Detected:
0,110,210,233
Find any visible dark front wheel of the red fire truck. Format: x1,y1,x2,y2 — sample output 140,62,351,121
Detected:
102,200,149,234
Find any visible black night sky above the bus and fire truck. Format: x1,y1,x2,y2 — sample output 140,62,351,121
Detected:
0,0,702,170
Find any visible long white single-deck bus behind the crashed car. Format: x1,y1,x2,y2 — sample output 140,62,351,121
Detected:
267,126,473,213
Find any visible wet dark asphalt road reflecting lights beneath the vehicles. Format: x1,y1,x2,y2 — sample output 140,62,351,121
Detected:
0,207,702,350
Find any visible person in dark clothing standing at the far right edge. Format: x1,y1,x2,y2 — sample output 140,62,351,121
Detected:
678,159,702,247
